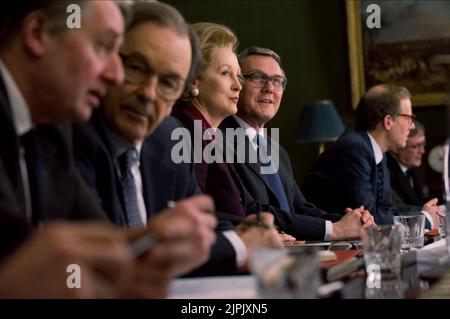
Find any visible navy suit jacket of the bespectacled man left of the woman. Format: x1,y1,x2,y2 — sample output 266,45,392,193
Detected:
73,112,236,276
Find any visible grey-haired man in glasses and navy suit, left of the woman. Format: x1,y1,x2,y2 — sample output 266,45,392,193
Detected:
74,3,281,275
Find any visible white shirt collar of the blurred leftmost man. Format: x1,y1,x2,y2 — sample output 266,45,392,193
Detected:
0,59,33,136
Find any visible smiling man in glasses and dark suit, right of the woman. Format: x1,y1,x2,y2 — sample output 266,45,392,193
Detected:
221,47,373,240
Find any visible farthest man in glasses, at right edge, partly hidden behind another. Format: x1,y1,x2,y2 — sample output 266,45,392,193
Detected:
387,120,437,219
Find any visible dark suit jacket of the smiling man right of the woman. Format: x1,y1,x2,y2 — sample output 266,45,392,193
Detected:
220,116,341,240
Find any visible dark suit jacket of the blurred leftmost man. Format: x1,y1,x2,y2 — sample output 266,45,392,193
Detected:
0,71,107,262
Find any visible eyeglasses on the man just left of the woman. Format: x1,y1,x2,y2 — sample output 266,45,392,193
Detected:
119,53,186,101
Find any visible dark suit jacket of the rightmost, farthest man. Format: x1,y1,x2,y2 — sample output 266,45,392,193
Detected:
387,153,425,206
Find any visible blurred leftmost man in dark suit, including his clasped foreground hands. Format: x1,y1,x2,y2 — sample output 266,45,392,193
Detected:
0,0,215,297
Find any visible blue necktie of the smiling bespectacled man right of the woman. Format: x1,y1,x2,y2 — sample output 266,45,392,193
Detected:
255,134,291,213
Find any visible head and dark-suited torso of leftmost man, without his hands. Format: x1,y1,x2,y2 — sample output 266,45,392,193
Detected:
0,1,123,246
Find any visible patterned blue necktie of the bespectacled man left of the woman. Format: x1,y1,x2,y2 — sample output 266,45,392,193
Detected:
119,147,144,227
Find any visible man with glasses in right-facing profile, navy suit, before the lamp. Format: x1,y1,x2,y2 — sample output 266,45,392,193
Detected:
302,84,440,226
